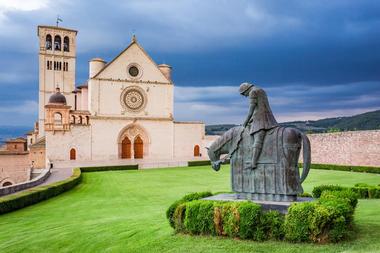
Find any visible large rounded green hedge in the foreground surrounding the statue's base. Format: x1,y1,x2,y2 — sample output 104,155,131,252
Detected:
167,190,357,243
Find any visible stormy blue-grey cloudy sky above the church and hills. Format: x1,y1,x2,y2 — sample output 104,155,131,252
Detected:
0,0,380,125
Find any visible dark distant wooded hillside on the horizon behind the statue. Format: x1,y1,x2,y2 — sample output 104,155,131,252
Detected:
206,110,380,135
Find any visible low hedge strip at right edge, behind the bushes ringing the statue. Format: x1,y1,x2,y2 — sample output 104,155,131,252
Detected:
313,183,380,199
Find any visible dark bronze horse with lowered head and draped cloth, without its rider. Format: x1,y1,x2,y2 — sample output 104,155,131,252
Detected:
208,126,311,201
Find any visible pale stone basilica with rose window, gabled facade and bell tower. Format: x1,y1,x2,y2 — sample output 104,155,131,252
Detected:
27,26,206,166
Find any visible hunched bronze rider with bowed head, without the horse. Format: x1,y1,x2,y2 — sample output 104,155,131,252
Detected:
239,83,278,169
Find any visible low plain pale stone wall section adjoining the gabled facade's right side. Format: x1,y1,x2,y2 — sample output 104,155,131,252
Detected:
174,122,207,158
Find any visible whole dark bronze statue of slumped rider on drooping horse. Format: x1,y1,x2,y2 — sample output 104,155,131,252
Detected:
208,83,311,201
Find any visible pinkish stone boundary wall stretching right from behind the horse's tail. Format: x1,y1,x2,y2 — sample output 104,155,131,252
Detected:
308,130,380,166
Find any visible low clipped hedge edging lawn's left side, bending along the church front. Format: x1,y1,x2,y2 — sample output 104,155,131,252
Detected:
0,165,138,214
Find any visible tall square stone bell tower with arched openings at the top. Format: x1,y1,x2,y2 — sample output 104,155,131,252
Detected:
37,26,78,137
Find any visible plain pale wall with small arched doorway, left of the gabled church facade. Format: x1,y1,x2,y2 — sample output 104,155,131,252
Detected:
46,125,91,162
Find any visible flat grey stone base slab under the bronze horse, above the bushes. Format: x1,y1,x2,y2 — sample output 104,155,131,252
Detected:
203,193,314,214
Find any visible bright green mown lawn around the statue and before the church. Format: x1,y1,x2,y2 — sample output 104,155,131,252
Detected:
0,166,380,253
